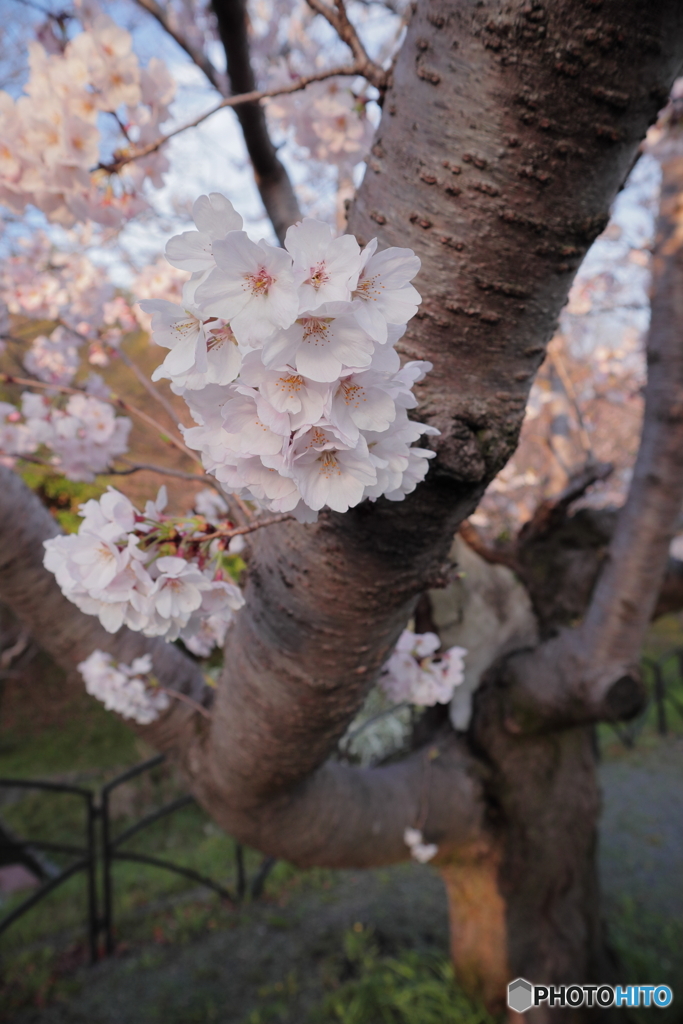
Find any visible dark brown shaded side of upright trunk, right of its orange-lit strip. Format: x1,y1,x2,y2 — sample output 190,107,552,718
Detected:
474,704,616,1022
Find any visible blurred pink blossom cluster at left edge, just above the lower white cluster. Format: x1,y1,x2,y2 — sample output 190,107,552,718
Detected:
0,391,132,481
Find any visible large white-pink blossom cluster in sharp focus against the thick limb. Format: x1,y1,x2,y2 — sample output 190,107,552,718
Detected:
140,193,438,521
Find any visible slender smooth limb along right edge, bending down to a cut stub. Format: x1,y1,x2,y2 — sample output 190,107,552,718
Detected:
501,151,683,727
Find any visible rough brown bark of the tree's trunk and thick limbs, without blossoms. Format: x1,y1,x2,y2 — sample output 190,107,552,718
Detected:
0,0,683,1019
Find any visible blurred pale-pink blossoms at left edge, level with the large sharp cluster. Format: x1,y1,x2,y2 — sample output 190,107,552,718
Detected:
0,231,136,384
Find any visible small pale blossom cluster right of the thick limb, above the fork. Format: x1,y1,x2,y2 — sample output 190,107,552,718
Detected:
379,630,467,708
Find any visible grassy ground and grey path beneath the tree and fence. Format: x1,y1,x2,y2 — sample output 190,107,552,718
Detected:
0,622,683,1024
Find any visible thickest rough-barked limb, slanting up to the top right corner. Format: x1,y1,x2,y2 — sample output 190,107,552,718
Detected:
0,0,683,865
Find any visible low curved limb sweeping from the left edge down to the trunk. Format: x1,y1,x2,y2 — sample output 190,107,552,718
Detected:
0,467,483,866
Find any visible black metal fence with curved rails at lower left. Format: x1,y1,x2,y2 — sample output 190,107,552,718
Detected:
0,754,275,964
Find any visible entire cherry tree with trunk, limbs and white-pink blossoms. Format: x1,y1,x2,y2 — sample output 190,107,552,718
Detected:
0,0,683,1019
